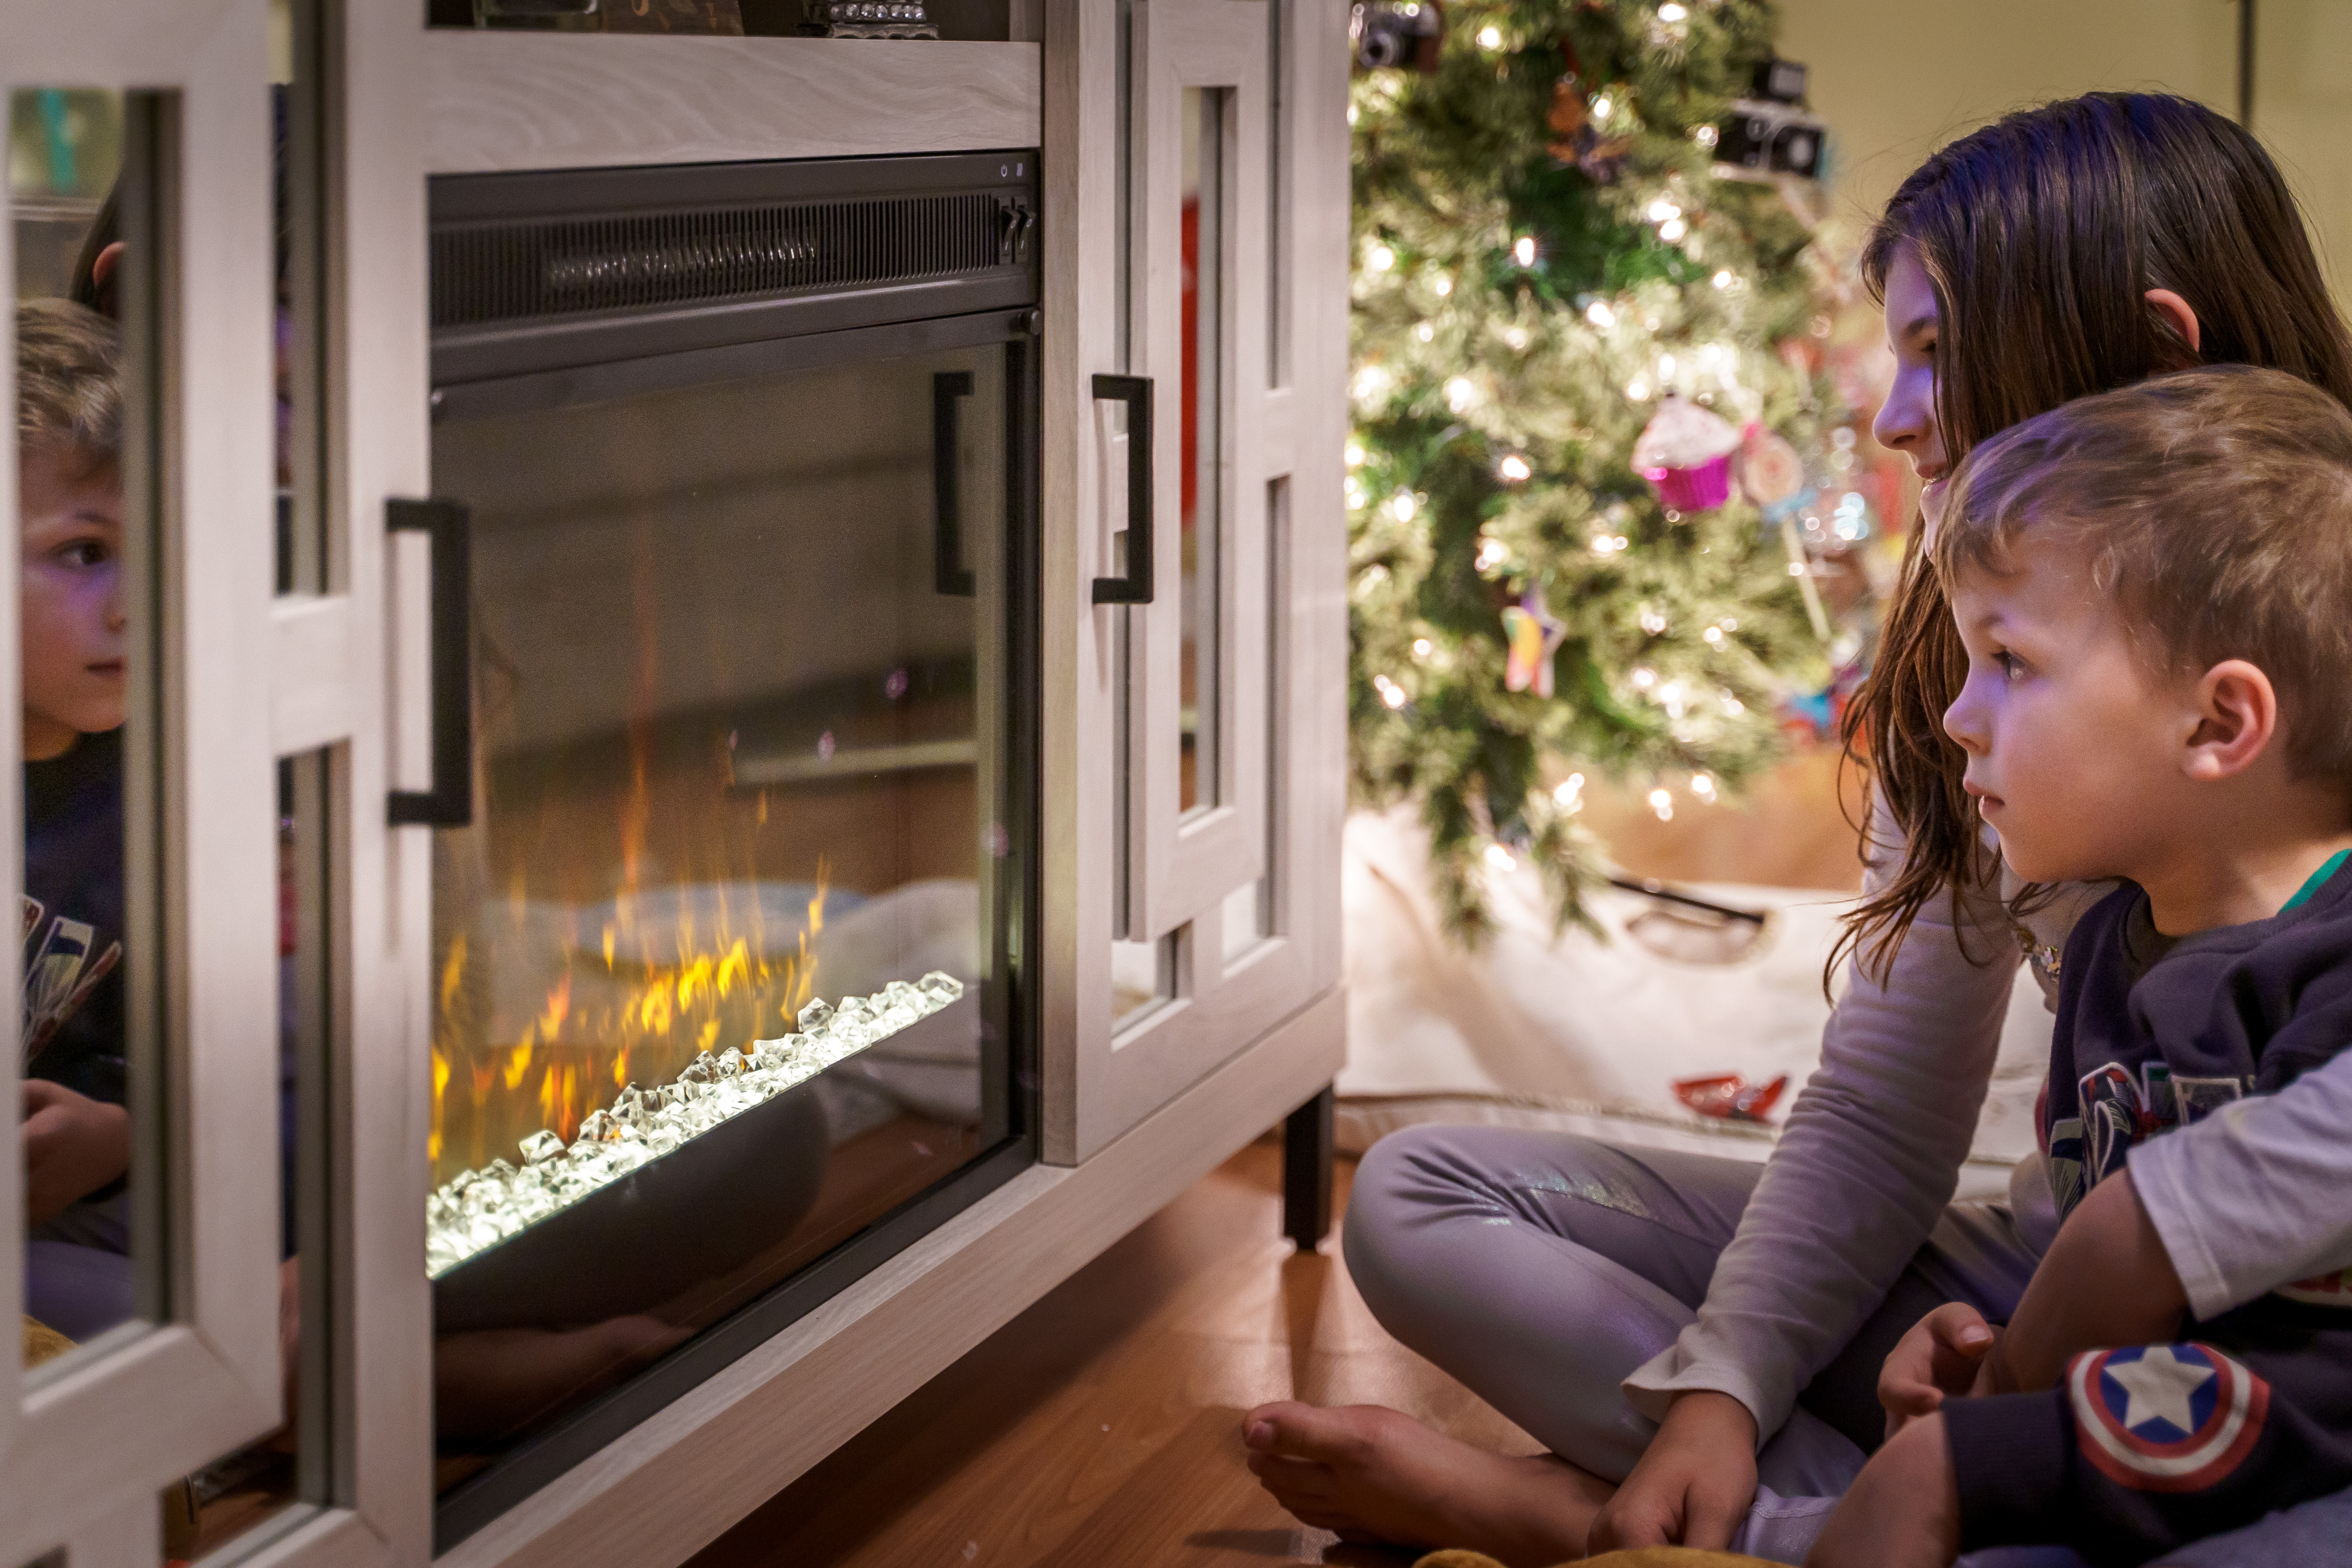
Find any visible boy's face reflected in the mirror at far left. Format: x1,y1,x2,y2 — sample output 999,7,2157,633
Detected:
16,446,125,759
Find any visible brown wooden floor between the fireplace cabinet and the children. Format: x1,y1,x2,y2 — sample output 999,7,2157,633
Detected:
691,1140,1538,1568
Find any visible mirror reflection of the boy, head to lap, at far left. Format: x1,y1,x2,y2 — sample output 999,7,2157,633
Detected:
16,301,132,1340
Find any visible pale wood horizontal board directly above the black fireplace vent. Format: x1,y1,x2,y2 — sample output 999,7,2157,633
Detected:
421,28,1042,174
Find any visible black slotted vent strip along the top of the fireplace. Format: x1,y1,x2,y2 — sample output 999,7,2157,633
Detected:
433,193,1035,327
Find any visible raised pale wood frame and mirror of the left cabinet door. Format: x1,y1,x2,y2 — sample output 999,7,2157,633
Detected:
0,0,282,1568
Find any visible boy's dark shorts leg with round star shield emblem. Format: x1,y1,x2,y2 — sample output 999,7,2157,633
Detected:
1943,1342,2352,1563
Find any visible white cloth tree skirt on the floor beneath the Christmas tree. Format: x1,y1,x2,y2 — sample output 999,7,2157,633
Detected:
1338,811,2051,1194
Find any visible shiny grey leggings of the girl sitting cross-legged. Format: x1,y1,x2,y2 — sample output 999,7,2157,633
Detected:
1343,1126,2352,1568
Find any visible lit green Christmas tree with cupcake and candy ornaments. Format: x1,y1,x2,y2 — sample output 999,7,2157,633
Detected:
1348,0,1842,943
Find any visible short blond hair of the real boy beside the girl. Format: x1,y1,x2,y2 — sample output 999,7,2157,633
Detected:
1933,365,2352,778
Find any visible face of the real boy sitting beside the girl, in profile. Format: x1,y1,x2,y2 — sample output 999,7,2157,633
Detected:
1943,534,2199,882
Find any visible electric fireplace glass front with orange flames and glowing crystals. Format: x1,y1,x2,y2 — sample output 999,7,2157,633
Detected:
428,325,1028,1488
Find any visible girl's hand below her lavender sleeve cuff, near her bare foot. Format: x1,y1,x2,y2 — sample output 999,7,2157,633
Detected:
1585,1389,1757,1554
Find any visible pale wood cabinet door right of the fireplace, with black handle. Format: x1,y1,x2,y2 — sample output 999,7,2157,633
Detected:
1047,0,1345,1159
